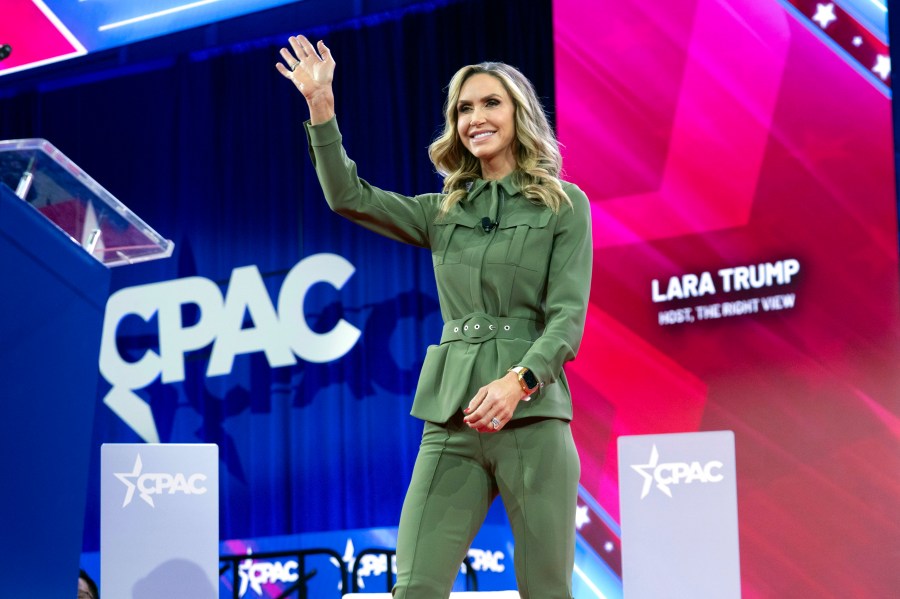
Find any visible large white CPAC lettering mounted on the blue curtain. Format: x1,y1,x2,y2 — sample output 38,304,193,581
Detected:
100,254,360,443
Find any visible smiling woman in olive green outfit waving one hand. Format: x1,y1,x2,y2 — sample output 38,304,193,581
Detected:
276,36,592,599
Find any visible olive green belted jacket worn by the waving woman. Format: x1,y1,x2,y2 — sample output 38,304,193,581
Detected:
306,118,593,422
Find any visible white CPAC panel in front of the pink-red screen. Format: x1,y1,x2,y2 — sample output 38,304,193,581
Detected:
618,431,741,599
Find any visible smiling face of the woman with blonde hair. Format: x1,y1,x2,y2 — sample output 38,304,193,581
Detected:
456,73,516,179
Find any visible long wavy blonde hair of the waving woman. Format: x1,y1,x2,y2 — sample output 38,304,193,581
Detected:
428,62,572,219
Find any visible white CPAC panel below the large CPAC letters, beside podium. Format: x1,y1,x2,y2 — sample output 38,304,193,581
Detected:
100,443,219,599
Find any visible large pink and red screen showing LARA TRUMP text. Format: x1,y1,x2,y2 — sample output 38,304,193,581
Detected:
554,0,900,598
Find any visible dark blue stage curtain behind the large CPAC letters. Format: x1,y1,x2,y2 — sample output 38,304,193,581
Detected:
0,1,553,551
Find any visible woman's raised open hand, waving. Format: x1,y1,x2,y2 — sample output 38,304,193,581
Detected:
275,35,335,124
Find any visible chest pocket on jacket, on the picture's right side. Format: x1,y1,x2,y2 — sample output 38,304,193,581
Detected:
485,205,553,272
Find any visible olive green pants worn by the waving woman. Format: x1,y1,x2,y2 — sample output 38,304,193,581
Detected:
393,414,581,599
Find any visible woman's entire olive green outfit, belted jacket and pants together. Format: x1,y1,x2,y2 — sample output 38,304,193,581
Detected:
306,118,592,599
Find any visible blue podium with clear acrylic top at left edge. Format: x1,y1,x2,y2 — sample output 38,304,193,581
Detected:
0,139,173,599
